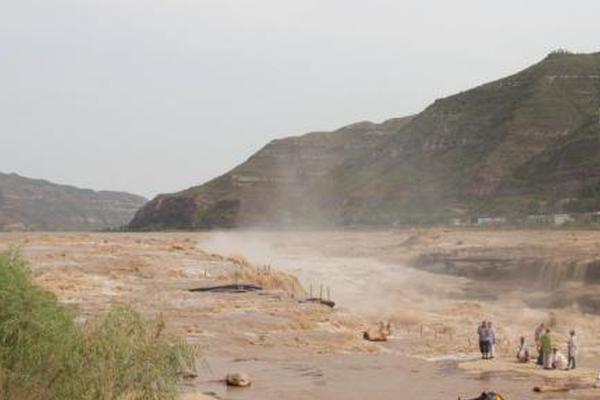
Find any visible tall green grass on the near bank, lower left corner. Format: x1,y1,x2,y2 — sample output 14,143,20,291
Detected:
0,252,195,400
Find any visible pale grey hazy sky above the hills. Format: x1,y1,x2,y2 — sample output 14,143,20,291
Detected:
0,0,600,196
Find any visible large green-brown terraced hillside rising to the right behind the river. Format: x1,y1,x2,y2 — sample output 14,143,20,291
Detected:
130,52,600,229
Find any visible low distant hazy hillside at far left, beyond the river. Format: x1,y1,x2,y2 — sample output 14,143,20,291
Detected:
0,173,146,231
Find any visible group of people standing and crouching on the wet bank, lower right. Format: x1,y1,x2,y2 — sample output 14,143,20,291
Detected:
477,321,579,370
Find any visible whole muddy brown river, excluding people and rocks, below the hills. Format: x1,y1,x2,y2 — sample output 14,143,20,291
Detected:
0,230,600,400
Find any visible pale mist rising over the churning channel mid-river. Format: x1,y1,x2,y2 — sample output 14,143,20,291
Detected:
200,231,474,319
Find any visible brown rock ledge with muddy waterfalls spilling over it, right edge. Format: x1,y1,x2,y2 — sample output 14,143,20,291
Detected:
406,230,600,314
